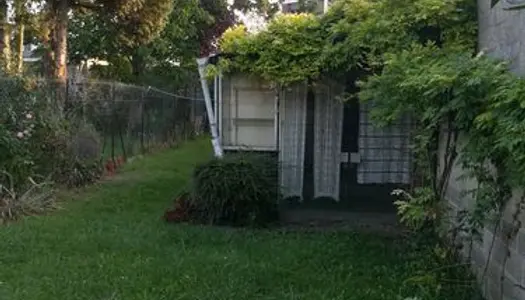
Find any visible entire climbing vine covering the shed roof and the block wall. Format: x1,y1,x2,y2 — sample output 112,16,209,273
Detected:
210,0,525,296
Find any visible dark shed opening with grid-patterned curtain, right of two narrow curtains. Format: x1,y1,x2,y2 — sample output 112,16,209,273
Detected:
340,100,412,212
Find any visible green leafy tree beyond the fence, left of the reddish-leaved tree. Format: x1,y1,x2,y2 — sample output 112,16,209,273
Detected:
69,0,201,82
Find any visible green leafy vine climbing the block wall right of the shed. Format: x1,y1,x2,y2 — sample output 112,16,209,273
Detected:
360,29,525,297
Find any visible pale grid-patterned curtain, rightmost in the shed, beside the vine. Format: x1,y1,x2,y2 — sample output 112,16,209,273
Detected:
357,104,411,184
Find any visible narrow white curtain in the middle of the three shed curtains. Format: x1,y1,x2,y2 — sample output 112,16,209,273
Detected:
314,85,344,201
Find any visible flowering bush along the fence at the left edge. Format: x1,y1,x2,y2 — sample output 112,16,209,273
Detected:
0,79,102,193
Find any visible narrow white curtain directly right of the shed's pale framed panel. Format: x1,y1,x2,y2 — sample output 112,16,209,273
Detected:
279,84,307,198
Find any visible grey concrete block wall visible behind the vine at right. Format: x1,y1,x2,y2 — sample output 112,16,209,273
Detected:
441,0,525,300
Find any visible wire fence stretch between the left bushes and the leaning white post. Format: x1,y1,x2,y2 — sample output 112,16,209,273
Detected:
66,81,206,158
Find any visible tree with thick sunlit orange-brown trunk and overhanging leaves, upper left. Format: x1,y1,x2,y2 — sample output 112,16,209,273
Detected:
42,0,172,85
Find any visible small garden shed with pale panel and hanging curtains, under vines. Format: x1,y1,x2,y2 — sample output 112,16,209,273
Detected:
214,73,412,211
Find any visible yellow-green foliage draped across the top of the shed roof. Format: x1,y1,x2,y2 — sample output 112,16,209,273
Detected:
213,0,477,84
